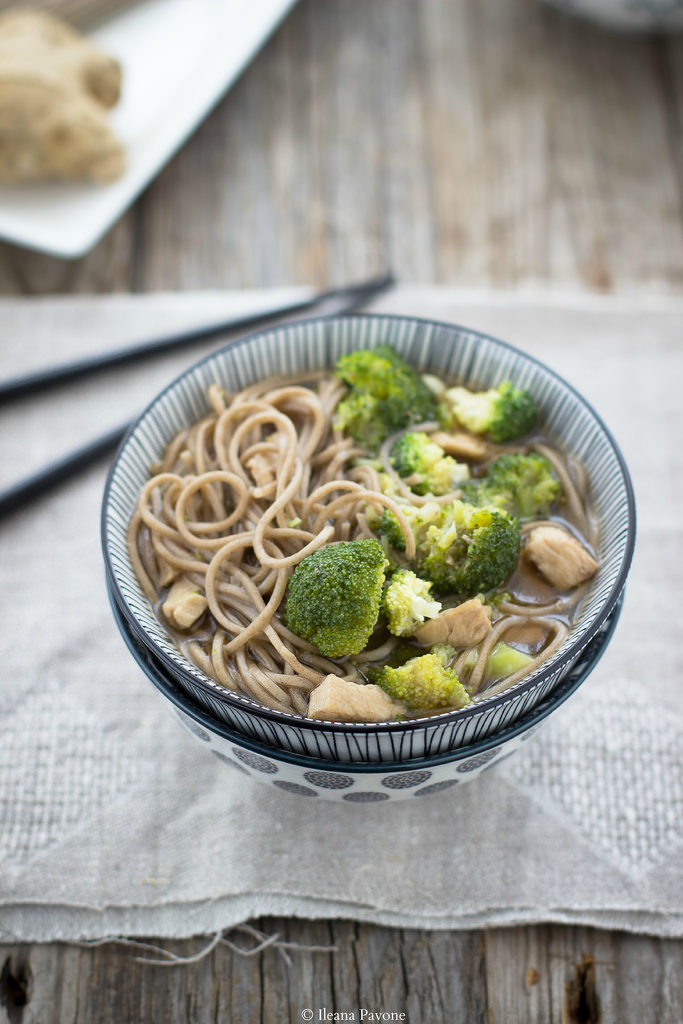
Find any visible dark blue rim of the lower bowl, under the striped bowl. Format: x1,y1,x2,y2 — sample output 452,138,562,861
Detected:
108,565,624,774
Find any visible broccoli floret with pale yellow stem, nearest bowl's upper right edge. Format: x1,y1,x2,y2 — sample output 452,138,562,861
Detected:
443,381,538,443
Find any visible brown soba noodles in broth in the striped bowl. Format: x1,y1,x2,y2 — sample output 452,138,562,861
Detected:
129,373,593,716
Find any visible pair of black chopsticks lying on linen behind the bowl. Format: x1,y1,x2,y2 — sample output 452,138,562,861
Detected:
0,271,395,518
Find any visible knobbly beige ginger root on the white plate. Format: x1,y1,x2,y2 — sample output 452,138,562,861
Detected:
0,10,124,183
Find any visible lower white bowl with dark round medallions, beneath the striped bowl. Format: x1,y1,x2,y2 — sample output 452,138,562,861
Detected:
112,585,622,804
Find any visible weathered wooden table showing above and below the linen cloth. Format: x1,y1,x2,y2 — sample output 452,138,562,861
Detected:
0,0,683,1024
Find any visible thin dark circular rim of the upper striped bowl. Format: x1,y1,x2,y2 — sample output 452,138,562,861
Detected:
100,313,636,734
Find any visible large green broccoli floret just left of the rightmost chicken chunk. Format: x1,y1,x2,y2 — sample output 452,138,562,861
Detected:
415,502,520,596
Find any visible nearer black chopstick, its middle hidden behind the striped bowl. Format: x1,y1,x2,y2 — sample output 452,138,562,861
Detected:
0,273,394,518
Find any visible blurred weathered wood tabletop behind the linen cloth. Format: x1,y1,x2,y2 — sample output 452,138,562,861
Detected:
0,0,683,294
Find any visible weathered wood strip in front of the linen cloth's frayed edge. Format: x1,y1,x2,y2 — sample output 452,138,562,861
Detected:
0,919,683,1024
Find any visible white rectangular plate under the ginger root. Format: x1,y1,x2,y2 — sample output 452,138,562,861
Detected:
0,0,295,258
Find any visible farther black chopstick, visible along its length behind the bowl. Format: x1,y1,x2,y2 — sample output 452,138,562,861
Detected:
0,272,394,404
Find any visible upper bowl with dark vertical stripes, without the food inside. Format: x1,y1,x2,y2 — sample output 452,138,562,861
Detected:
102,314,635,762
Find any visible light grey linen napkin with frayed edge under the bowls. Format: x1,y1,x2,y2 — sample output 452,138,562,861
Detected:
0,288,683,941
